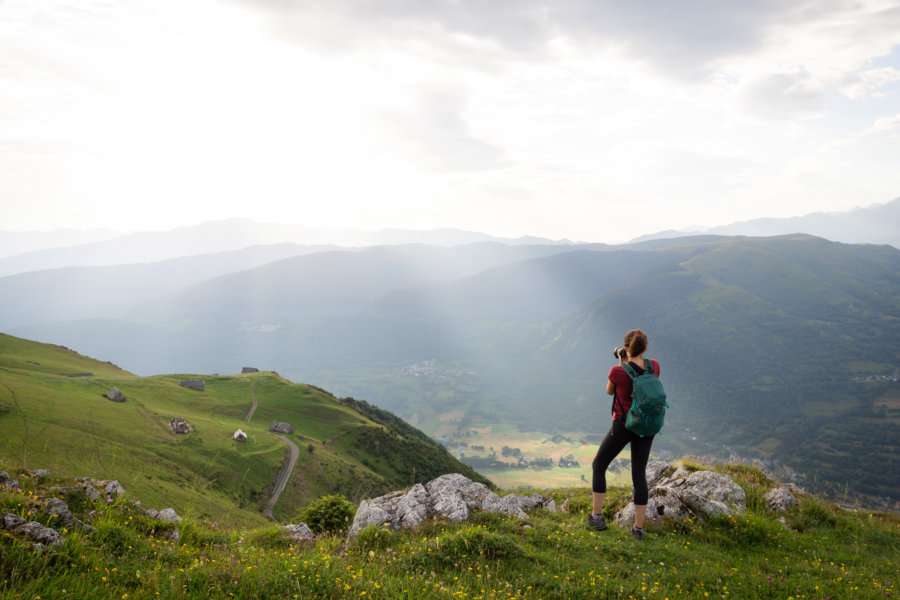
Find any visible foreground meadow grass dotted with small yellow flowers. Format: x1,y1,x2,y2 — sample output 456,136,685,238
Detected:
0,468,900,600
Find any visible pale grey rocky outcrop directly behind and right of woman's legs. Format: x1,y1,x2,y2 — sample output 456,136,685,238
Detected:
615,461,747,527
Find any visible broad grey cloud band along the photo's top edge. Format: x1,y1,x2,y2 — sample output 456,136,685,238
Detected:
234,0,788,74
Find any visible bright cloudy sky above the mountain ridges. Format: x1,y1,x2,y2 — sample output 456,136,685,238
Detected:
0,0,900,243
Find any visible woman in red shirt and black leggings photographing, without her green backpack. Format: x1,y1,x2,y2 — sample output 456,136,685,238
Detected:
588,329,659,540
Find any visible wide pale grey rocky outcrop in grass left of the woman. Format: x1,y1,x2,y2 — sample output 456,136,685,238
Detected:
348,473,556,539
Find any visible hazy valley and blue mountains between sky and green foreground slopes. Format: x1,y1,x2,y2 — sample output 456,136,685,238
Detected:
0,200,900,506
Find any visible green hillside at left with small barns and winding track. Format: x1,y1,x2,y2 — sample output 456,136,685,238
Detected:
0,334,487,525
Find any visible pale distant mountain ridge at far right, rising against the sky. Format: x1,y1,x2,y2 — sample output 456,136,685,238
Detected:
632,198,900,248
